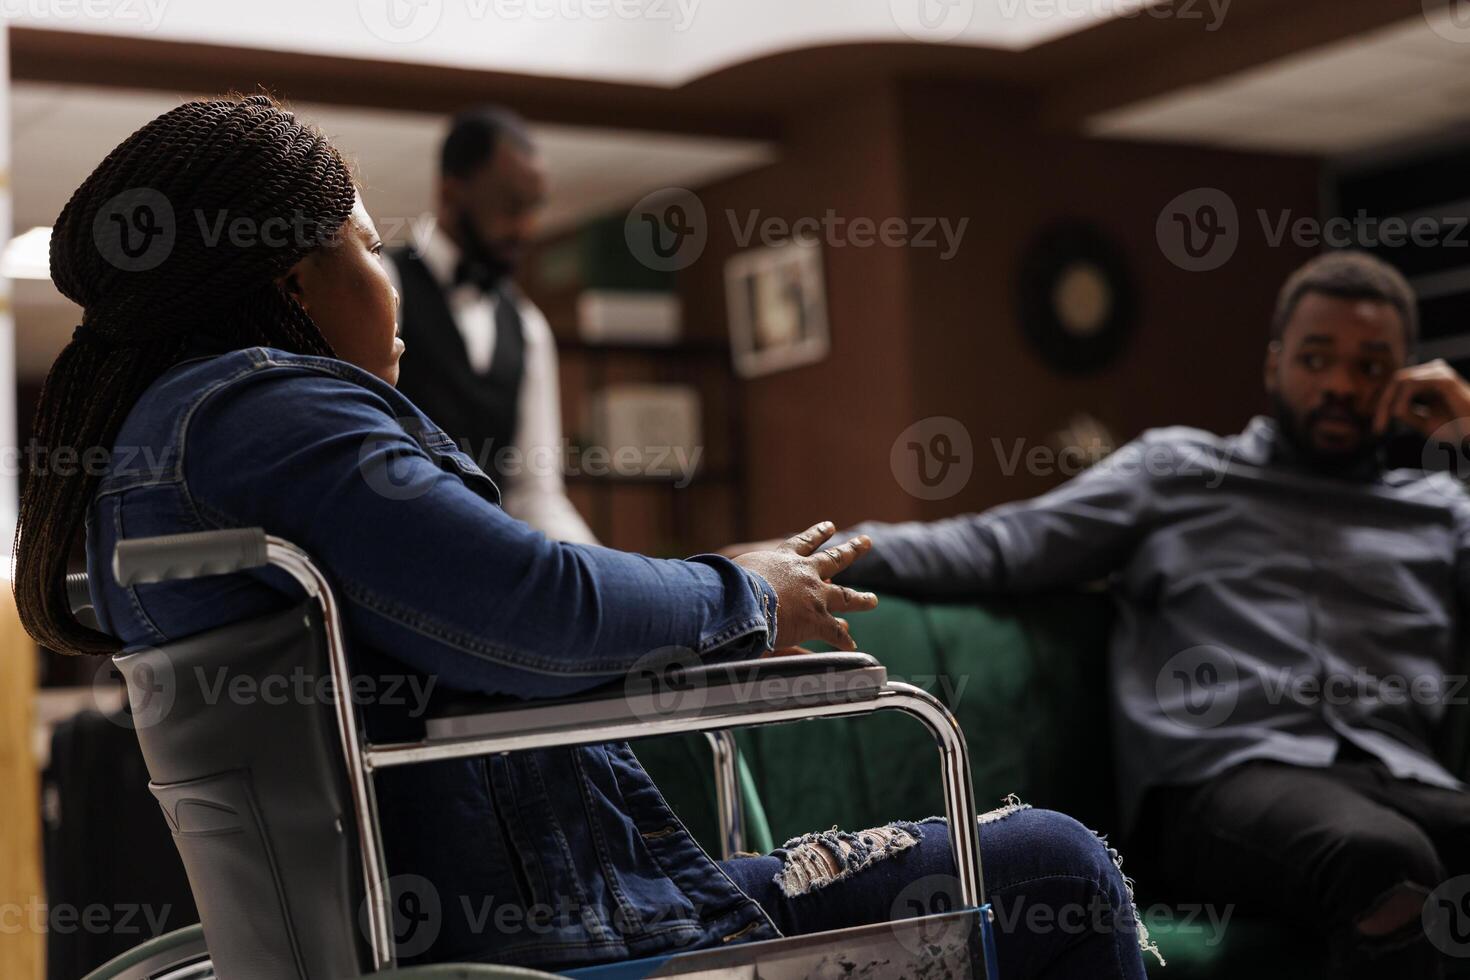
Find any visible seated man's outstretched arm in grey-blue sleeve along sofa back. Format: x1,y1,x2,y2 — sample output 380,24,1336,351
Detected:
838,436,1152,597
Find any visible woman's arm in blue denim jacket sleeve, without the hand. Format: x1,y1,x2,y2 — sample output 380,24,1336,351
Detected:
184,364,776,696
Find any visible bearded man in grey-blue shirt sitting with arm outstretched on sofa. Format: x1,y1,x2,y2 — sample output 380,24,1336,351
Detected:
838,253,1470,977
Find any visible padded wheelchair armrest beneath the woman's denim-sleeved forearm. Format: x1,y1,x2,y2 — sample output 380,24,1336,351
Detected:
425,654,888,742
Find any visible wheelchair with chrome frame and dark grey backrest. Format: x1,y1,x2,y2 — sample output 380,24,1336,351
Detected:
77,527,998,980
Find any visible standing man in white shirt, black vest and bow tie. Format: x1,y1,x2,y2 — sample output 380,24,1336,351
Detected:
388,106,597,544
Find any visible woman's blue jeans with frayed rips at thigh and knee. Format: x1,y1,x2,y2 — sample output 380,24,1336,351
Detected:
720,802,1150,980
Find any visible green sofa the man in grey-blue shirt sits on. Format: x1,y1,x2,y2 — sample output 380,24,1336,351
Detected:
635,592,1352,980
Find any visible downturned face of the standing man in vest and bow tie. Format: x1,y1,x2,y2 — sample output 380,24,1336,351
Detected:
442,143,547,267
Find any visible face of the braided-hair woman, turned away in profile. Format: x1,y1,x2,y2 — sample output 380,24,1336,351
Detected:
282,195,403,385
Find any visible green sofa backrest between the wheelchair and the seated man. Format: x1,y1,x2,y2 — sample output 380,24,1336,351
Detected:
741,595,1116,840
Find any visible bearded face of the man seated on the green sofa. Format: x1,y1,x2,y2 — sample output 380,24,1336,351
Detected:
1266,292,1407,466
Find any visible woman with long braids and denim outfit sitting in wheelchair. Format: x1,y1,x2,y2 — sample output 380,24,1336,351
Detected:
15,96,1147,980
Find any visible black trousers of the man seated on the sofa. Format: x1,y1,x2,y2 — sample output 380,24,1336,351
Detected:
1130,746,1470,979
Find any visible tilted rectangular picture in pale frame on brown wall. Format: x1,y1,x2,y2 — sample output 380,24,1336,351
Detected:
725,241,831,378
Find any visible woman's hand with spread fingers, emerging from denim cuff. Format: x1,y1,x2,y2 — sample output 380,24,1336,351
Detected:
734,520,878,649
